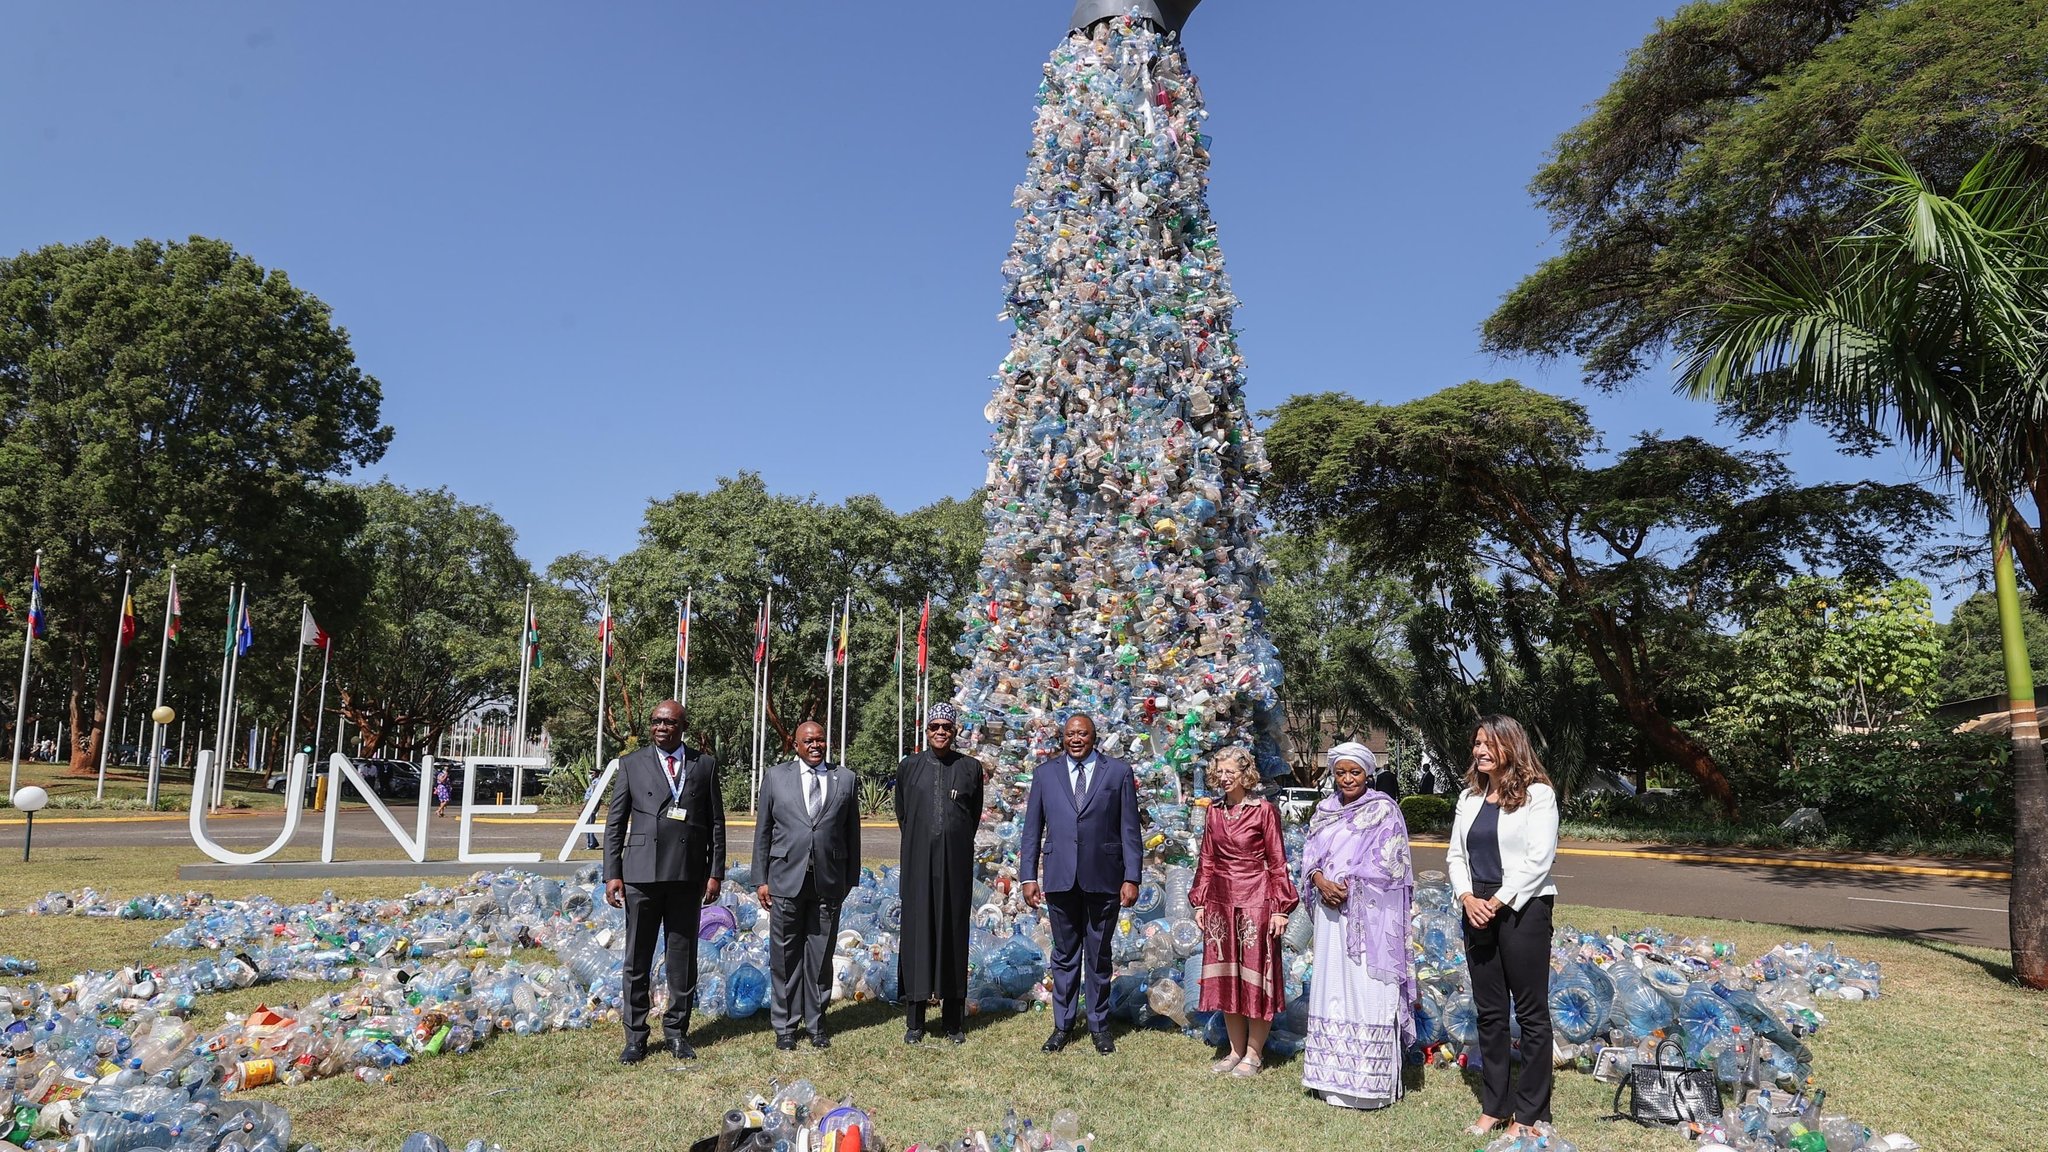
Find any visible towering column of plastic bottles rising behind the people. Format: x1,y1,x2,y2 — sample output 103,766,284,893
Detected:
956,18,1282,812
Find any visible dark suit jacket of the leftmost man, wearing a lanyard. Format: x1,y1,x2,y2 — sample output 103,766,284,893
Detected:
604,744,725,883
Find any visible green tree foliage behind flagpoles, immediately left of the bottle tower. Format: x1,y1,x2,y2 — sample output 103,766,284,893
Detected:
535,474,983,778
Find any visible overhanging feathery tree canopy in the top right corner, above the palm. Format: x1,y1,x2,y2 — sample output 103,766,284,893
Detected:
1485,0,2048,389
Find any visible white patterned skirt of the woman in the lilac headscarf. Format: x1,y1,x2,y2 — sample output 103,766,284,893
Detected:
1300,900,1401,1109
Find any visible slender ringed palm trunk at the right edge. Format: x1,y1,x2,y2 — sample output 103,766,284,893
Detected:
1991,523,2048,988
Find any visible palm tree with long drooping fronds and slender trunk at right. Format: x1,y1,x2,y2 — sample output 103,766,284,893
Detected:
1679,148,2048,988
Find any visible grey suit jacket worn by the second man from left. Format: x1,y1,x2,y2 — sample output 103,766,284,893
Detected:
754,760,860,904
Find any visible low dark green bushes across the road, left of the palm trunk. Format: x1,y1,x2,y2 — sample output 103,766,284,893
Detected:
1780,722,2013,838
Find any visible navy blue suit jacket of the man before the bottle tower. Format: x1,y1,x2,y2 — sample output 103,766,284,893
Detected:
1018,752,1145,894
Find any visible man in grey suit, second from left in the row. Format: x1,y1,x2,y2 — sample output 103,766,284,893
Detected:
754,722,860,1052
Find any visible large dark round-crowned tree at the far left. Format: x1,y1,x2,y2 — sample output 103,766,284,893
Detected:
0,238,391,771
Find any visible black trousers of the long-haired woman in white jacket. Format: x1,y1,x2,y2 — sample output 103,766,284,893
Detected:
1464,890,1556,1123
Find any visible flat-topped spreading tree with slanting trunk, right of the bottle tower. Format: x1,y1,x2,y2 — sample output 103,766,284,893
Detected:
1268,381,1942,812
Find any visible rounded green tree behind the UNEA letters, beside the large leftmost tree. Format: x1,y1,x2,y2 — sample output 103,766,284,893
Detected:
331,482,532,758
